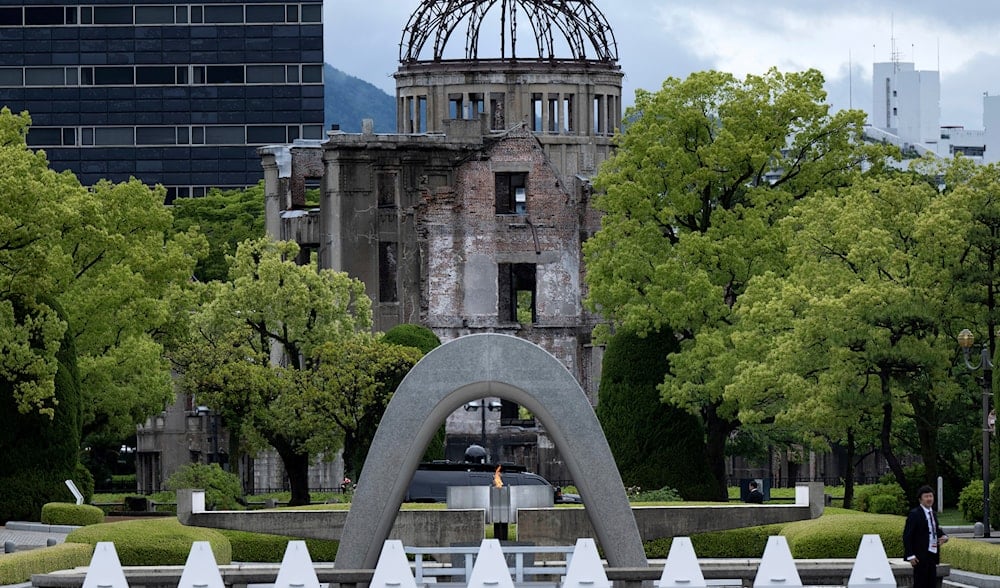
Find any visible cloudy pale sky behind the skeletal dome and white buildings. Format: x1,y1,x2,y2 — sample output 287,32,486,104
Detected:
324,0,1000,129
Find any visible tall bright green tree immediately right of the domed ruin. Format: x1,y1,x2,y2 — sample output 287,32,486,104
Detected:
584,70,878,500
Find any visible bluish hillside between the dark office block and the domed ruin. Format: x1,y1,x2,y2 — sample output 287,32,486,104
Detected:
323,63,396,133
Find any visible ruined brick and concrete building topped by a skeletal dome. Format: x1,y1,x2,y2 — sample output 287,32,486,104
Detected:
259,0,622,482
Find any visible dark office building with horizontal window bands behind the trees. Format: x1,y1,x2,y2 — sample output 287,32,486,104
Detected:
0,0,323,201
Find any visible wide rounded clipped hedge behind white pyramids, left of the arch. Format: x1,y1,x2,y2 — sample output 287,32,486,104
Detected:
66,518,232,566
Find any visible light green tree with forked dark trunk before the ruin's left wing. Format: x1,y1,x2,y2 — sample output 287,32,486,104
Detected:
174,239,371,505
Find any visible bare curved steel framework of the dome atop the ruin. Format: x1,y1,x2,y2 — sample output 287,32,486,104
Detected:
399,0,618,63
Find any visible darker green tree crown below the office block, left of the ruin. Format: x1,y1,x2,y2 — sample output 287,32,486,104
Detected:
173,180,264,282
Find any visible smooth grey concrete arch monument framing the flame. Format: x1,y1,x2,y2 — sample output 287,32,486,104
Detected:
336,333,648,569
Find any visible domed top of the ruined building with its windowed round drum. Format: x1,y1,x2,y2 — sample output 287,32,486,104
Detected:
395,0,622,140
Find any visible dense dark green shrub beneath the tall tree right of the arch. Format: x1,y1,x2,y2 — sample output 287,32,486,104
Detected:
597,331,715,500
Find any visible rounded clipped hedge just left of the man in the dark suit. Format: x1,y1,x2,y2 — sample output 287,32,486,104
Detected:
781,514,903,559
